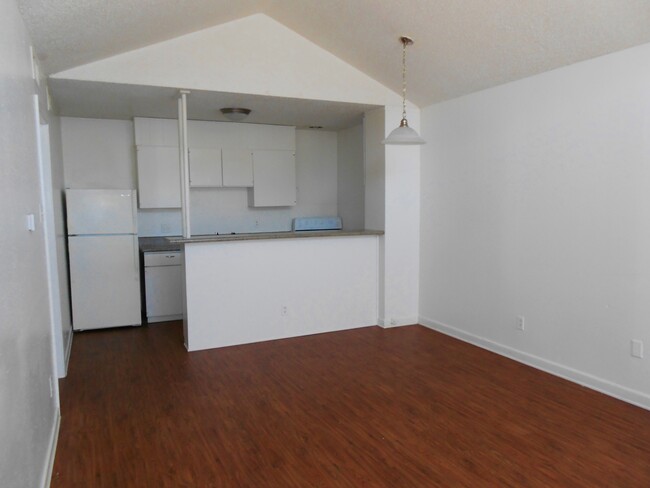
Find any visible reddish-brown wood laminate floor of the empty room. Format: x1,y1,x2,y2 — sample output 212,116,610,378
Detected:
52,322,650,488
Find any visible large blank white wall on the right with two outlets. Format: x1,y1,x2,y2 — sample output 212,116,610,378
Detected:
420,45,650,408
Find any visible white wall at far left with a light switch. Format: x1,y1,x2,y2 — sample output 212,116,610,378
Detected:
0,1,58,488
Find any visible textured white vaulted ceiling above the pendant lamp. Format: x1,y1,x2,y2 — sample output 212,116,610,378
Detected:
17,0,650,106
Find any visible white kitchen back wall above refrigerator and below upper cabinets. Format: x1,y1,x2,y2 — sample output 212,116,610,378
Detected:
61,117,337,236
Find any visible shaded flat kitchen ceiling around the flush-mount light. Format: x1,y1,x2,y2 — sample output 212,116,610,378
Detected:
48,78,378,130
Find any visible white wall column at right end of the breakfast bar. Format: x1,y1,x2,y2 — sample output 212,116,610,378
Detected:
364,106,420,327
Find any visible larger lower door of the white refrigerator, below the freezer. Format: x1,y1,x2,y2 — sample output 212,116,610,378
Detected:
68,235,142,330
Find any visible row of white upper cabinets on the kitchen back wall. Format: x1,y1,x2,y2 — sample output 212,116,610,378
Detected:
133,117,297,208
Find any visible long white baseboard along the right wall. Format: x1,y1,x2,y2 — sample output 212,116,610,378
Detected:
419,317,650,410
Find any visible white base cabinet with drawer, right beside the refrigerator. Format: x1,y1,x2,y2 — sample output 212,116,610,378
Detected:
144,251,183,324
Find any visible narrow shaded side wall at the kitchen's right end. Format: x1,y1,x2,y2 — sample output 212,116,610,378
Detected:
337,125,365,229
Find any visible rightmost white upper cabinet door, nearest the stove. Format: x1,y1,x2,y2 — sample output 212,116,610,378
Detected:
252,151,296,207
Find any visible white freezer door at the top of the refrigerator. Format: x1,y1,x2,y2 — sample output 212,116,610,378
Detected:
66,190,138,235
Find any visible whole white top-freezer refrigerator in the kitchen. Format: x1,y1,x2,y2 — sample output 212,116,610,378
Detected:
66,190,142,330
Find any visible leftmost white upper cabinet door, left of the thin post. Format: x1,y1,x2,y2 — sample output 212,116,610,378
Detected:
137,146,181,208
